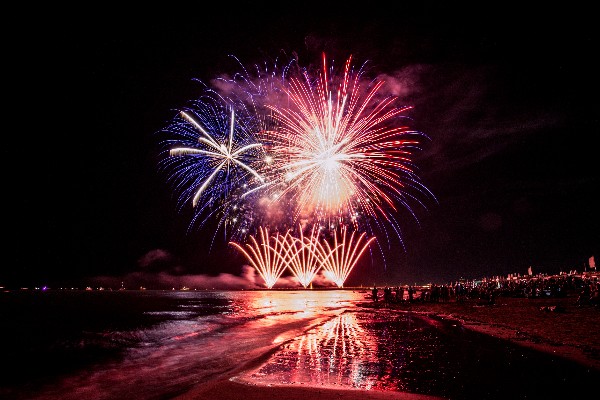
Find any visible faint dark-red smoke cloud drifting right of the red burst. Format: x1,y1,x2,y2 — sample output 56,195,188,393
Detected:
379,64,565,173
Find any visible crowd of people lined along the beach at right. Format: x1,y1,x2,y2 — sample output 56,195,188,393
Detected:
371,272,600,308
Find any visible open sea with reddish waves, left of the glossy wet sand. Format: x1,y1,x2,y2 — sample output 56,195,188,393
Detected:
0,290,364,399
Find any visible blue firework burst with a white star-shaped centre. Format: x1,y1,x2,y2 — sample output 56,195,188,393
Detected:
159,95,265,242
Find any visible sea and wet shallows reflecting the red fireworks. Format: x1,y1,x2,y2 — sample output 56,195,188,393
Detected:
0,289,599,400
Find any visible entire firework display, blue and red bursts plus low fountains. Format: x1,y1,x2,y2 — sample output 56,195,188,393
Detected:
161,54,435,288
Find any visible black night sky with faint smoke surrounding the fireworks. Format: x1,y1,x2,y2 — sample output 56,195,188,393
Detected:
0,2,600,286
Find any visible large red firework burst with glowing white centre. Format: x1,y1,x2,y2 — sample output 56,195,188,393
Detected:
259,55,433,244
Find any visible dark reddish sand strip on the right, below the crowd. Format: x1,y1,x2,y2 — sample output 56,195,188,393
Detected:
376,296,600,371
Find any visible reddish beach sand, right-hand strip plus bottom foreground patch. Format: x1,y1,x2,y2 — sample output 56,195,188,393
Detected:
177,296,600,400
